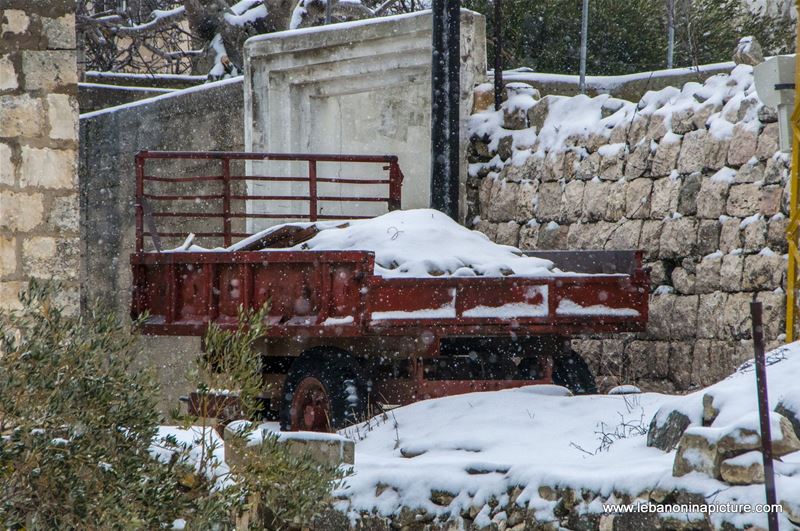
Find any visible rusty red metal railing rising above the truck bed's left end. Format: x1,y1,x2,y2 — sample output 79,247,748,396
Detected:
134,151,403,253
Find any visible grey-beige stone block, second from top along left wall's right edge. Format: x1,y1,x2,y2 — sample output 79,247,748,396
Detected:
22,50,78,92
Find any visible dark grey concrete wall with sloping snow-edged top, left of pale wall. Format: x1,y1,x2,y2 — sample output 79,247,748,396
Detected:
79,78,244,411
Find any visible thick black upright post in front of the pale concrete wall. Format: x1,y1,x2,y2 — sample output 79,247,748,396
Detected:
431,0,461,220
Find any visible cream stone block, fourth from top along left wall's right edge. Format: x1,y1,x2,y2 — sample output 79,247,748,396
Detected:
19,146,77,190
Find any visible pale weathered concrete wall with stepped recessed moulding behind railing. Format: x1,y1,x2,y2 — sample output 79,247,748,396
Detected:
245,10,486,226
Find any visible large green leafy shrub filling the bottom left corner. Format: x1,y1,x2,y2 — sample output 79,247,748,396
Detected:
0,283,228,529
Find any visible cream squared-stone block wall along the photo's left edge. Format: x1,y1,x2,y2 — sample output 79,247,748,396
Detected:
0,0,80,312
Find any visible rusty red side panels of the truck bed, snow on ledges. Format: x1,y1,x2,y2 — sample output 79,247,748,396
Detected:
131,250,648,337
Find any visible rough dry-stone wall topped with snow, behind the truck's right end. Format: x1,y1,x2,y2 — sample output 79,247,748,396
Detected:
468,65,789,391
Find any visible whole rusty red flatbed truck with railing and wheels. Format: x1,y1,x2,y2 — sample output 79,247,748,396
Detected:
131,152,649,431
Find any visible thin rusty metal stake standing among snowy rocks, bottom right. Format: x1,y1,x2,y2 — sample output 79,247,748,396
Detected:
750,302,778,531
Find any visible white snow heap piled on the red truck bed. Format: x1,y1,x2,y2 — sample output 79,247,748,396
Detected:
228,209,557,277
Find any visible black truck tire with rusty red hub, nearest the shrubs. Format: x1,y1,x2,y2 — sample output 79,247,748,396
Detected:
280,348,367,432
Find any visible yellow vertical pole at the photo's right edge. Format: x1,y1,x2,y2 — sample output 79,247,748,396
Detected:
786,8,800,343
